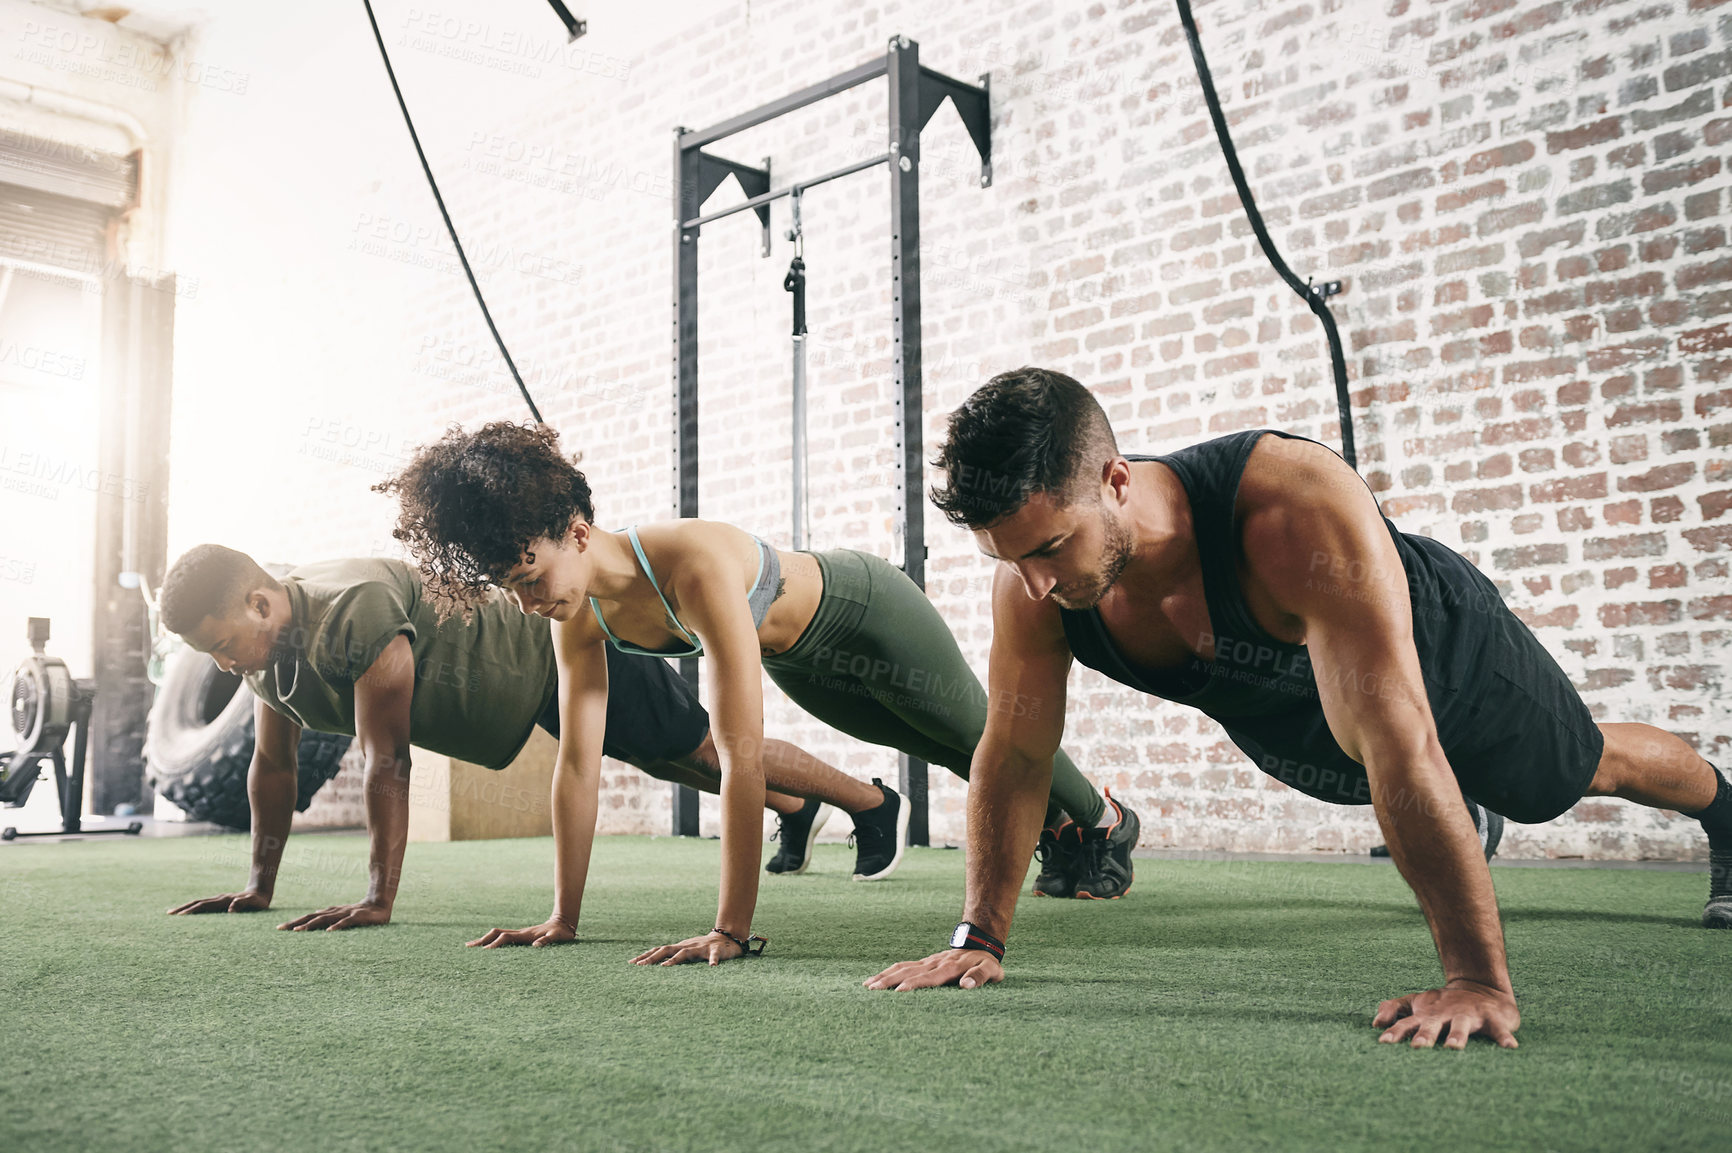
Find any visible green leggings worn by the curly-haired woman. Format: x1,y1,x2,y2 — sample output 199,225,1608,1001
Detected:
764,549,1107,826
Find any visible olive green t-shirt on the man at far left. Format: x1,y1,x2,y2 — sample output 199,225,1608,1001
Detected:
246,559,558,769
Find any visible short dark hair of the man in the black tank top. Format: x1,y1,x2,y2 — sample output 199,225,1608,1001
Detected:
932,369,1119,530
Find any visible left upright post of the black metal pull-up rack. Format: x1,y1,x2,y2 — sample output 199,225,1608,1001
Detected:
674,128,703,836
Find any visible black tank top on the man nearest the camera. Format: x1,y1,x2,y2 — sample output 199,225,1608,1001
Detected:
1060,429,1509,805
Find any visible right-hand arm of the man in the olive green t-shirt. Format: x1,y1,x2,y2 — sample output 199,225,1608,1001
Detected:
281,635,416,930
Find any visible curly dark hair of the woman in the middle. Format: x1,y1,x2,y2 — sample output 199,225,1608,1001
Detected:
372,421,596,620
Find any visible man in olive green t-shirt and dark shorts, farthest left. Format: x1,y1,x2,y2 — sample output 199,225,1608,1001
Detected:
161,544,882,930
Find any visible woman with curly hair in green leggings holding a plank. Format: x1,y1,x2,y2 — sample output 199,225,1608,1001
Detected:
376,421,1136,964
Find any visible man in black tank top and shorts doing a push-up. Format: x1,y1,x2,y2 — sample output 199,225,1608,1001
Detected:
868,369,1732,1047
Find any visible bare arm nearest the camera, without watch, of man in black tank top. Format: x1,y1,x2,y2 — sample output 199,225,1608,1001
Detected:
1240,436,1519,1047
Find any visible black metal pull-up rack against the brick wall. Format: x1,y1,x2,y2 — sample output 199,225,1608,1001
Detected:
674,36,992,845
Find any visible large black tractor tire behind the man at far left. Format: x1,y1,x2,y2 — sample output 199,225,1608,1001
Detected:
144,649,353,829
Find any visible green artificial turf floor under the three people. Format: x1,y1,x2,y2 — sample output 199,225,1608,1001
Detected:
0,834,1732,1153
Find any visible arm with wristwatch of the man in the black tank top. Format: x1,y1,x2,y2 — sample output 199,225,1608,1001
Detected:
866,566,1070,990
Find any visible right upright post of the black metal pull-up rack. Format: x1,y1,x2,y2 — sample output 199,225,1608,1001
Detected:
889,36,930,845
